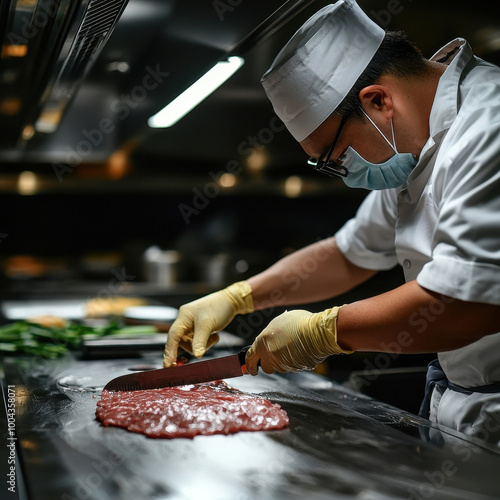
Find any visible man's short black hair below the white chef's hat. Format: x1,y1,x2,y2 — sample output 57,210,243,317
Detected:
335,31,427,119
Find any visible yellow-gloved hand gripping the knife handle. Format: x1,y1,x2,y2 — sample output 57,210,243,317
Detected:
245,307,353,375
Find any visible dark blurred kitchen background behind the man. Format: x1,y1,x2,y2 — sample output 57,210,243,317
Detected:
0,0,500,396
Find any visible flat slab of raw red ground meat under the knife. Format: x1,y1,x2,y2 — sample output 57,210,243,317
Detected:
96,380,288,438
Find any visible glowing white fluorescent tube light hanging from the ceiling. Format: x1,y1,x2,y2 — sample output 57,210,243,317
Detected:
148,56,245,128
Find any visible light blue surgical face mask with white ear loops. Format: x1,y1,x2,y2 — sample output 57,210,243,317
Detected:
340,110,418,190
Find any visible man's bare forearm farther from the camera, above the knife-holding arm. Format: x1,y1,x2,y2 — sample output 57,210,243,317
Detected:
248,237,375,310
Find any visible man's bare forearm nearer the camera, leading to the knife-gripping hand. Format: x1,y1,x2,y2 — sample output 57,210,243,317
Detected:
337,281,500,353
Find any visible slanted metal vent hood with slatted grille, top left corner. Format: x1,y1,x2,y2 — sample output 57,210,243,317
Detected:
0,0,128,145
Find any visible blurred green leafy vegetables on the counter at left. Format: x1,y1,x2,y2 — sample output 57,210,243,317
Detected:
0,321,158,358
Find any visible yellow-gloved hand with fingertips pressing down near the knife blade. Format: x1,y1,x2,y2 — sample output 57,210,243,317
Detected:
163,281,254,368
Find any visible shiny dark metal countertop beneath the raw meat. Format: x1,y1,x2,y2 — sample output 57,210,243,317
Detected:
0,351,500,500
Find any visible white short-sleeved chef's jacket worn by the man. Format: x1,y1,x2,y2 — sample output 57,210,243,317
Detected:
336,38,500,444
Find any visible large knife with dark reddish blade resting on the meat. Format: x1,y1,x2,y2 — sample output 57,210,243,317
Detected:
103,346,254,391
